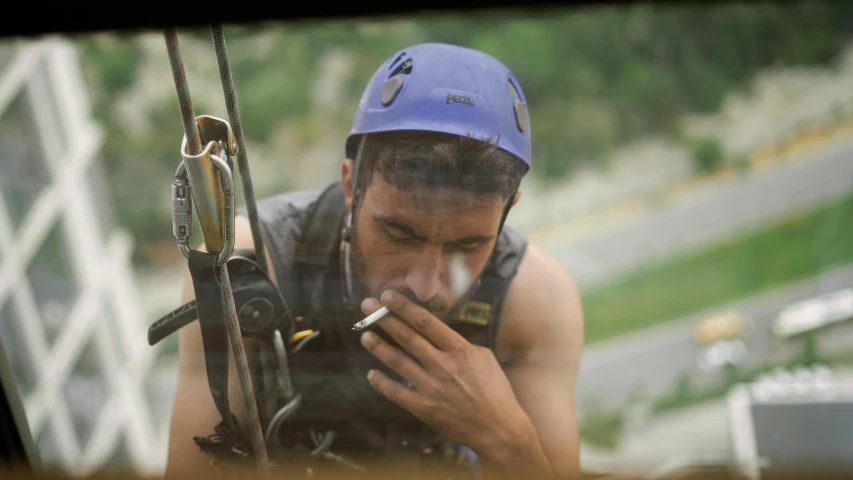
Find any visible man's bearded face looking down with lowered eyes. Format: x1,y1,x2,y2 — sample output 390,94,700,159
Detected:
351,173,505,318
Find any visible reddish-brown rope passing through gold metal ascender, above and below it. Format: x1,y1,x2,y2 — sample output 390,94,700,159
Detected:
165,27,270,473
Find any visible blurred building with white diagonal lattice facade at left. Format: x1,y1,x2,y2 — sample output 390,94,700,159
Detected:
0,37,168,473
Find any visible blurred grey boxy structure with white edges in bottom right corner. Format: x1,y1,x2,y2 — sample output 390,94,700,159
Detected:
727,364,853,480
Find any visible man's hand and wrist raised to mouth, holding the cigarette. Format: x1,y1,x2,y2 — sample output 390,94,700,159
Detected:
361,291,553,476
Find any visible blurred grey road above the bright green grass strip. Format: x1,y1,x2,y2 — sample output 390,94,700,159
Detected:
542,139,853,289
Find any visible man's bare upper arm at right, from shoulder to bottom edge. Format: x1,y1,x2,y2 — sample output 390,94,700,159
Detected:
497,245,583,478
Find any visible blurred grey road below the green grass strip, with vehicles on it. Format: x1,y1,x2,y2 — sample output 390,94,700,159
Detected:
576,265,853,406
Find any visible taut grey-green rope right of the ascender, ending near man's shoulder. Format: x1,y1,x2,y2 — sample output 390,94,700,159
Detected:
210,24,269,273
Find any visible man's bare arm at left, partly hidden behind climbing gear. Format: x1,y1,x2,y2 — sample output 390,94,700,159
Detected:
165,216,276,478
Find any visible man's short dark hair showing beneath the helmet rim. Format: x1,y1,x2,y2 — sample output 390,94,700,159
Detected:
350,131,526,199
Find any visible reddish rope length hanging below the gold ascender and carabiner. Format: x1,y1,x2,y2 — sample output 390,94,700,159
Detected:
219,266,270,473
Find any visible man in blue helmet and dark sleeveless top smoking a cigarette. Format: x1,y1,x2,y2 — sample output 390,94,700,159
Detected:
166,44,583,478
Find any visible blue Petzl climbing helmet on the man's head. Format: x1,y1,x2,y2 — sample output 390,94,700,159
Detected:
346,43,530,172
